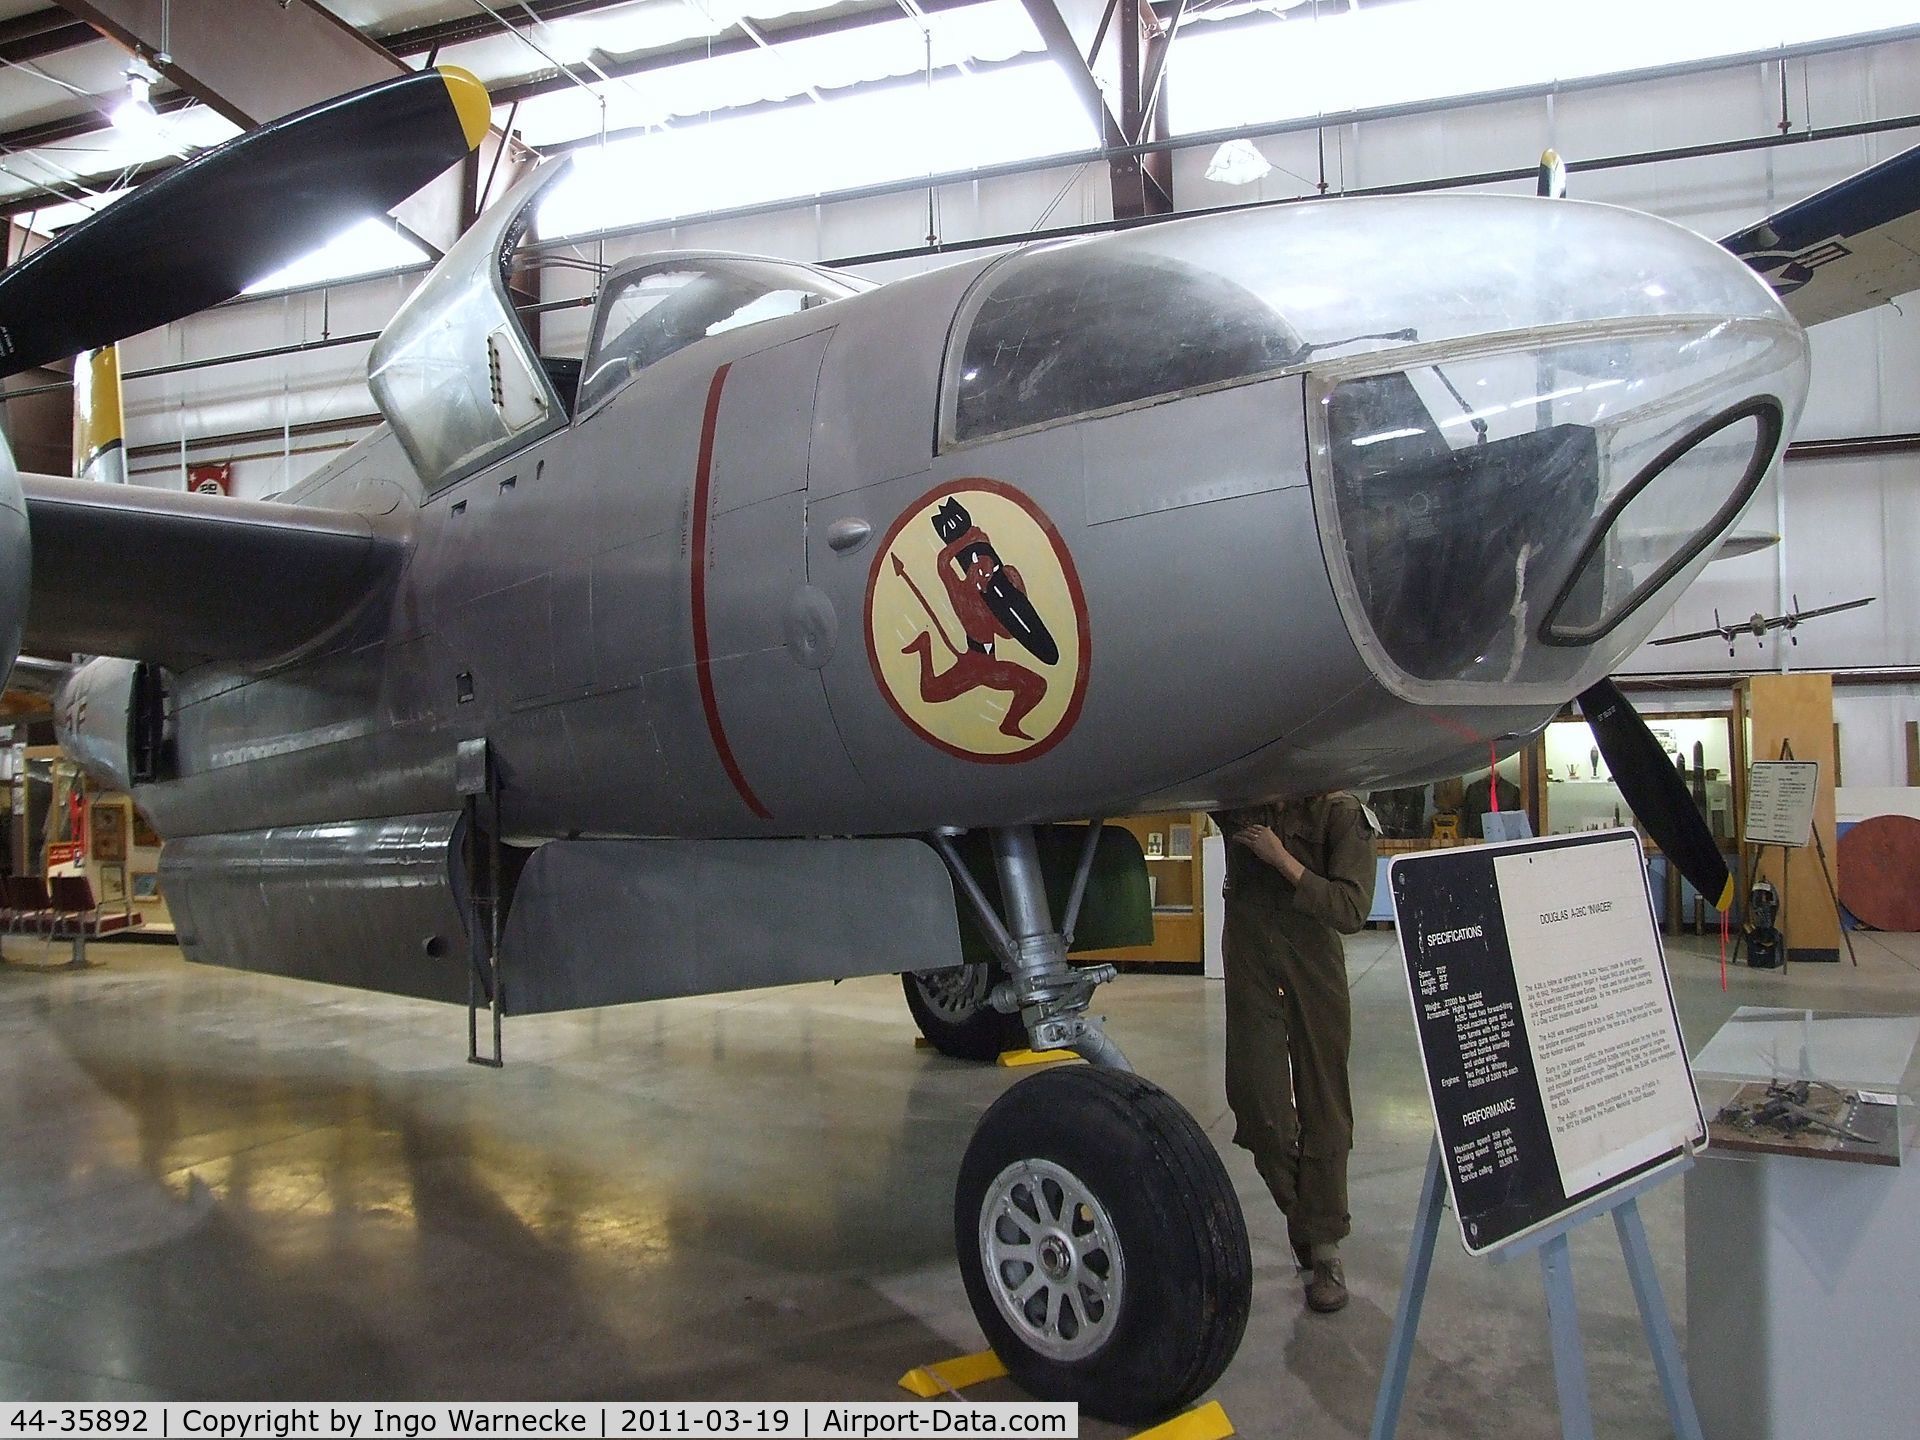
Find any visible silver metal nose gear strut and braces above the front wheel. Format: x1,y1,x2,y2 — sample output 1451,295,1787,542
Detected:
916,822,1131,1069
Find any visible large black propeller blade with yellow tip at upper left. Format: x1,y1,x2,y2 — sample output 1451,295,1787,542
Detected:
0,65,492,374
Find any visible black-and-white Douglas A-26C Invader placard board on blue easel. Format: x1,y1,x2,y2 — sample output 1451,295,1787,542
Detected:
1388,829,1707,1254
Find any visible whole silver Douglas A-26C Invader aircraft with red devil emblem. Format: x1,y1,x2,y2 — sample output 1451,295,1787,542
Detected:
0,71,1914,1417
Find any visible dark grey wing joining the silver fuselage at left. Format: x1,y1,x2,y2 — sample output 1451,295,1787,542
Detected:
19,474,407,670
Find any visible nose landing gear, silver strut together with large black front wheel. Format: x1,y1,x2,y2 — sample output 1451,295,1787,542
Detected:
921,824,1254,1421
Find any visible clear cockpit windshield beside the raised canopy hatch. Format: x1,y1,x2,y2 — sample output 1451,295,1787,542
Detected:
580,253,860,415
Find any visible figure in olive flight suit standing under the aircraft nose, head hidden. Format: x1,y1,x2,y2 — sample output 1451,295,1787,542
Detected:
1213,793,1375,1311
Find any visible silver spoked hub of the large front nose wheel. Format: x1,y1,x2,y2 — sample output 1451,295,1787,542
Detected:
979,1160,1125,1361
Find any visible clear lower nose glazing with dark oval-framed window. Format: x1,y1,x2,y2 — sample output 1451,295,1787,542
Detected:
1315,321,1805,703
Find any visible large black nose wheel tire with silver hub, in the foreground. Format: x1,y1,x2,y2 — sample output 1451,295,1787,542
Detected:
954,1066,1254,1423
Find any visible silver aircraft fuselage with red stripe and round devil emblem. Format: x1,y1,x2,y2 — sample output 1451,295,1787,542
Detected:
60,177,1807,856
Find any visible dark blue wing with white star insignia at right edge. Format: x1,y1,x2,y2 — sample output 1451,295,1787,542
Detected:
1720,148,1920,324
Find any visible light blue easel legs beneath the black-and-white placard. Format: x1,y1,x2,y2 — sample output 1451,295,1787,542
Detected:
1367,1137,1701,1440
